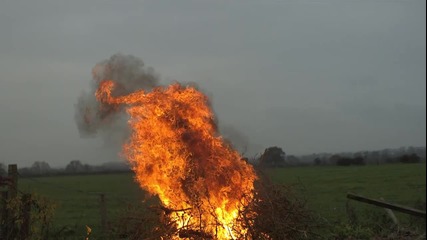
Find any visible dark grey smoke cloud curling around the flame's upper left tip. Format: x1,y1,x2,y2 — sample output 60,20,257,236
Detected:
75,54,159,144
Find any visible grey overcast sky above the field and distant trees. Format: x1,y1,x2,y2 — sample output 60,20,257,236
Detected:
0,0,426,166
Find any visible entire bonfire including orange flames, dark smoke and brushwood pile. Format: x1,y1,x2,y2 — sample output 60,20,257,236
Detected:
75,54,308,239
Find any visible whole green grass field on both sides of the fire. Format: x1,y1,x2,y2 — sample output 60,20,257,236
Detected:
19,164,426,236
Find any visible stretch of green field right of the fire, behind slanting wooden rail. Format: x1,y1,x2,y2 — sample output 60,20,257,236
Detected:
267,164,426,221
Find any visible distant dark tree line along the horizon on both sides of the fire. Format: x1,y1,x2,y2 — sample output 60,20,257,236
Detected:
0,146,426,176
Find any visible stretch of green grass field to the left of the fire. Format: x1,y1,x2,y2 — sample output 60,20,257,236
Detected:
0,166,149,239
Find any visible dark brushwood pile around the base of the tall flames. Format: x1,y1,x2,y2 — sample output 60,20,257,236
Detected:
111,172,314,240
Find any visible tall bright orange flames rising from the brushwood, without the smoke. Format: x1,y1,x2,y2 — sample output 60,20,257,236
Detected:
96,80,256,239
